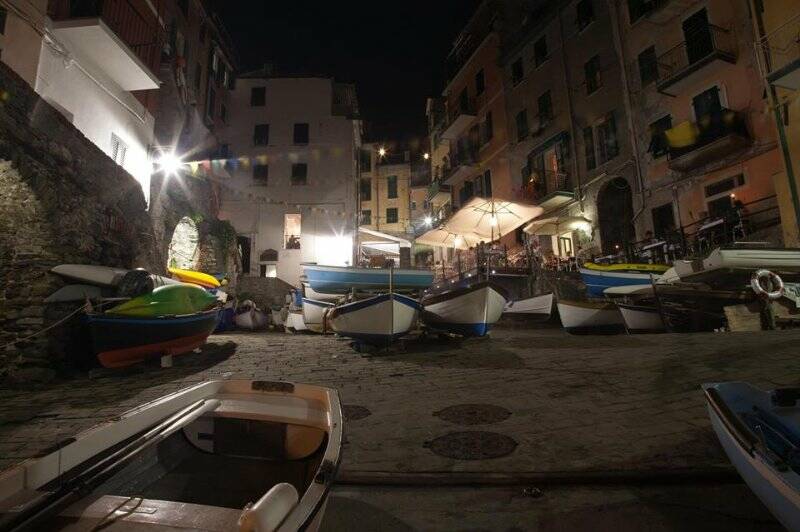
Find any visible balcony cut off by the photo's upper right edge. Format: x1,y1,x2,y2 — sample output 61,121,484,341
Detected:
756,13,800,90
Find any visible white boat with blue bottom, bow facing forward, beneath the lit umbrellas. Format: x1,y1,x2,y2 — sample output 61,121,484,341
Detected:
422,281,507,336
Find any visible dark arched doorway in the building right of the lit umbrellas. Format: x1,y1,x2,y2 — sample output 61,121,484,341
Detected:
597,177,636,254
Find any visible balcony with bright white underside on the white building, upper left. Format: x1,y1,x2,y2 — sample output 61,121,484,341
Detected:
48,0,161,91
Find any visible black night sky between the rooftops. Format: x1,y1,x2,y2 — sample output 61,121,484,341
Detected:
209,0,479,142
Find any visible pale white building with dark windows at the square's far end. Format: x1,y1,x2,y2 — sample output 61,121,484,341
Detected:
220,72,361,286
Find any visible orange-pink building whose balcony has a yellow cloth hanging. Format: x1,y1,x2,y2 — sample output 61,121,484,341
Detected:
609,0,780,248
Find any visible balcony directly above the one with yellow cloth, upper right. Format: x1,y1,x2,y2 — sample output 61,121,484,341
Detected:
656,25,736,96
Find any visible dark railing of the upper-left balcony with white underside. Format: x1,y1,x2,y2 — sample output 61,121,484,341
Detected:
48,0,161,70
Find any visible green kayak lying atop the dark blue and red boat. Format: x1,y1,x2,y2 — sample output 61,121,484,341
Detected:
106,283,217,318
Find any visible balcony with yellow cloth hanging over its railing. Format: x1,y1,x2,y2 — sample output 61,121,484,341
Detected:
664,109,751,172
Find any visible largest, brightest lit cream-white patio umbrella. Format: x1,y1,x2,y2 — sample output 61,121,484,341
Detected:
446,198,544,242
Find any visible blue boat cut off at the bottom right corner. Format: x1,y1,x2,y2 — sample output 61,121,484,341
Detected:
703,382,800,531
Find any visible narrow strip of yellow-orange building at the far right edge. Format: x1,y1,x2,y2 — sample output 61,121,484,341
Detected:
750,0,800,247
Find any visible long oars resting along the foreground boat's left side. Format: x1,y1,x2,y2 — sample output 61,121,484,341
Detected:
5,399,219,532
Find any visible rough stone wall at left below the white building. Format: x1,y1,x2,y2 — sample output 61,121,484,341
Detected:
0,64,157,382
